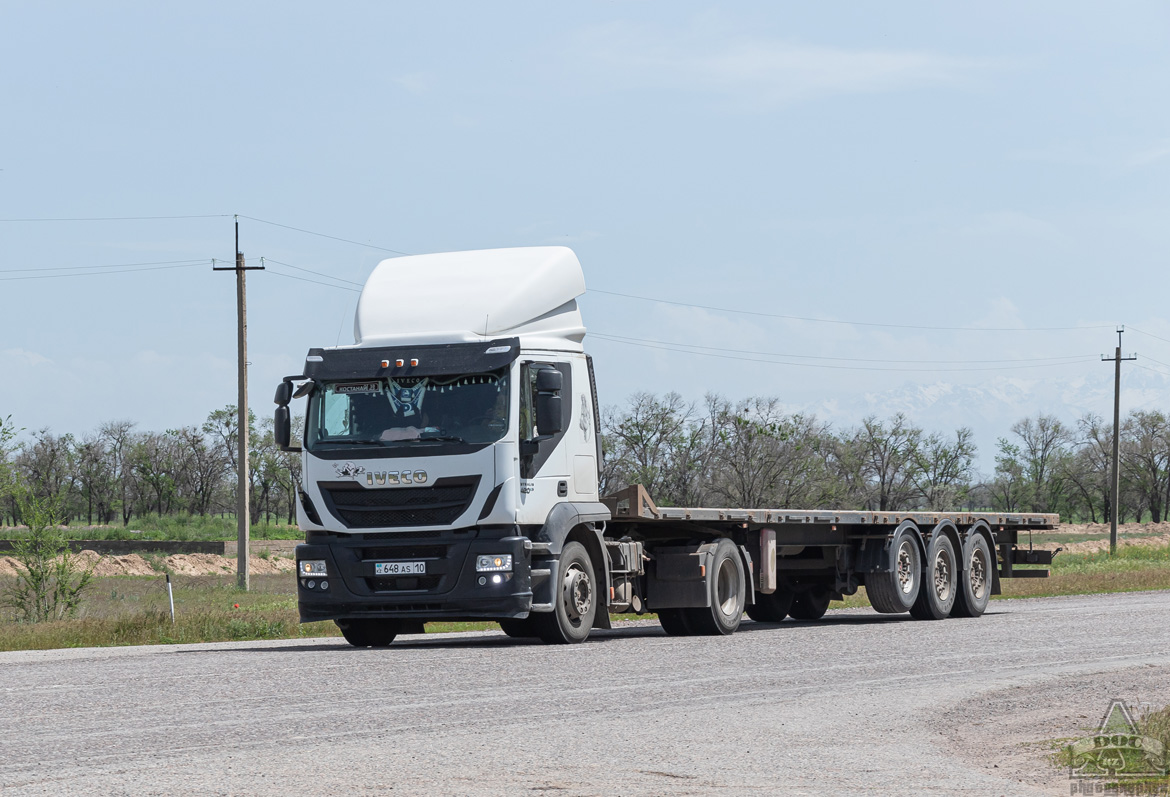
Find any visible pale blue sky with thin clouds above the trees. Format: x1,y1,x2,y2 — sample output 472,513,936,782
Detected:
0,0,1170,469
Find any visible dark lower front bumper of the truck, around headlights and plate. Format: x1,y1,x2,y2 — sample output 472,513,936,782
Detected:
296,529,532,623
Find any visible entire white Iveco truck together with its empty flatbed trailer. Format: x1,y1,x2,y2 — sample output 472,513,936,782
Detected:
276,247,1058,646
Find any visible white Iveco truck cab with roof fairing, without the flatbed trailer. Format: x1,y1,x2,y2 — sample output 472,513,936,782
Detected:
276,247,610,644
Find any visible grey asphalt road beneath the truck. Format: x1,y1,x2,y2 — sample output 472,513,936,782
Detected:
0,592,1170,796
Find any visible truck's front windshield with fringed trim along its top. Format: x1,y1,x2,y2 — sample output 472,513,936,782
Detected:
307,369,509,449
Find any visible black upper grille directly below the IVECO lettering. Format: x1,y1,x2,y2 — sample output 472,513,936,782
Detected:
321,476,480,529
